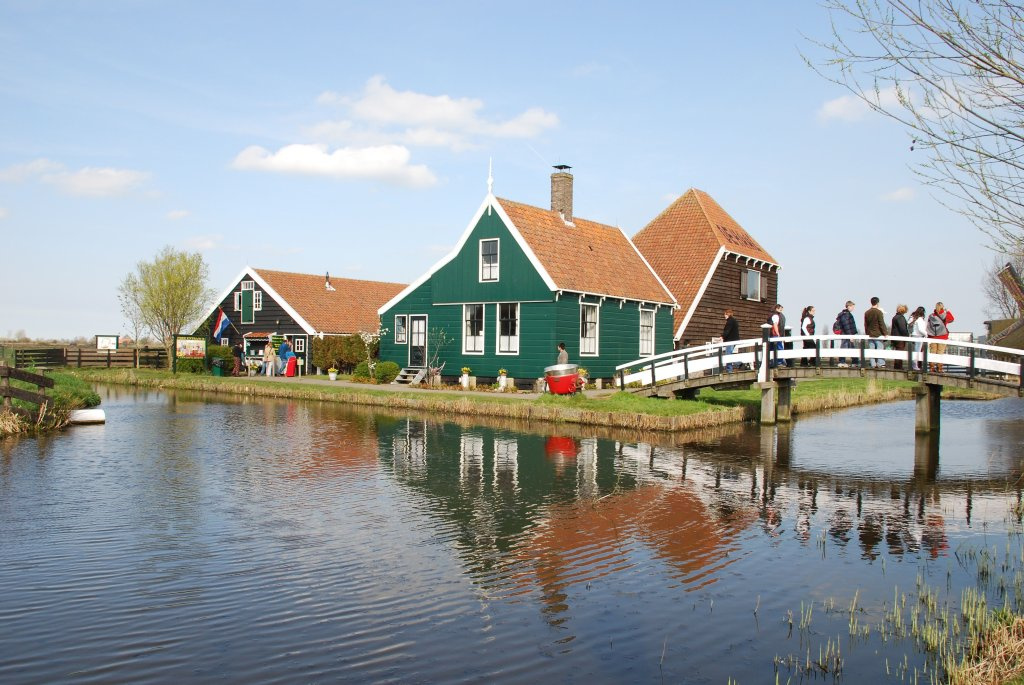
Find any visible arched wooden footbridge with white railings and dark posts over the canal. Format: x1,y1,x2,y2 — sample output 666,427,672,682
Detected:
615,328,1024,433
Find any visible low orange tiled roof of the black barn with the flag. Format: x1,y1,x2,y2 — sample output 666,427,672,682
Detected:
253,269,406,334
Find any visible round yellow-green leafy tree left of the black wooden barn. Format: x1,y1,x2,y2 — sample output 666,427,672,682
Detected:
119,246,215,365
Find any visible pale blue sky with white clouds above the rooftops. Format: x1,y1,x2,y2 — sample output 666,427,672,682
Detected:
0,0,993,338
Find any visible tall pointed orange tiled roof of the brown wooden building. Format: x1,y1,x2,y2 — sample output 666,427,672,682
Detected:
633,188,778,331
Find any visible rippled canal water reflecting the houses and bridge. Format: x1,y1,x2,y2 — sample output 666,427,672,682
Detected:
0,389,1024,684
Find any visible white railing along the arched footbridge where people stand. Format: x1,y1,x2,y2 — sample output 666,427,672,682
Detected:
615,335,1024,388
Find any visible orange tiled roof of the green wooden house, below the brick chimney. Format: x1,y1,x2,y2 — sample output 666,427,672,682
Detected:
498,198,673,303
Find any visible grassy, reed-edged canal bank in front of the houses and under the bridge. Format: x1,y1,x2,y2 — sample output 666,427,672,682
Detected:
67,369,983,431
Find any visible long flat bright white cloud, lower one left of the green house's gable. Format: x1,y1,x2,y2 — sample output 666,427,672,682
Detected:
231,144,437,187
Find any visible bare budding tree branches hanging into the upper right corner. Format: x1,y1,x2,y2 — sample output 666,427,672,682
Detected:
805,0,1024,253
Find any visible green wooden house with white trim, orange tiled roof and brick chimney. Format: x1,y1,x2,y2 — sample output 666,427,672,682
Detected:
379,164,675,379
